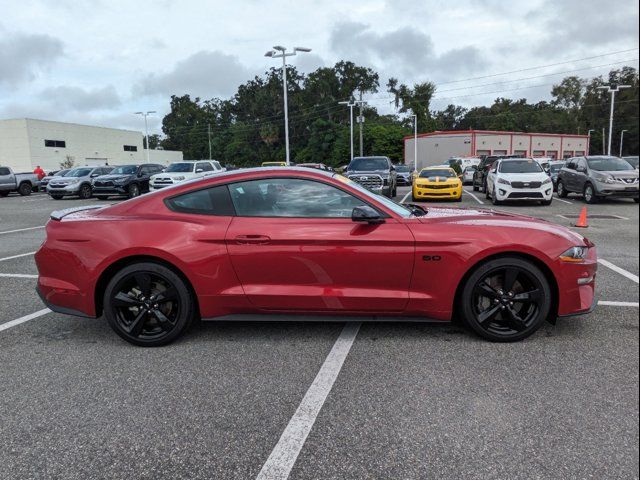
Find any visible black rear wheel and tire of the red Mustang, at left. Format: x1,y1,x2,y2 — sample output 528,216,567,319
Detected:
103,262,196,347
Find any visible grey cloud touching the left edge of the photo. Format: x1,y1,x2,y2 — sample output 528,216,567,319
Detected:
0,32,64,86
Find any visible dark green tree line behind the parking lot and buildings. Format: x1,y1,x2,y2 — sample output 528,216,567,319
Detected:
149,61,639,167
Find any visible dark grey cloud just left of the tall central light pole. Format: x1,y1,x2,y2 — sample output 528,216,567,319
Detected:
133,51,253,98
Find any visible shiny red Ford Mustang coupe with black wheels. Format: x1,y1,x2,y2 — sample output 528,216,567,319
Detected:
36,168,597,346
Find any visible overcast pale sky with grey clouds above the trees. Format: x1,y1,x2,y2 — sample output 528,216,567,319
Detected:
0,0,638,132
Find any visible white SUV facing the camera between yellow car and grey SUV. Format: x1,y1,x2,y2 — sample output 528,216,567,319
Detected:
486,158,553,205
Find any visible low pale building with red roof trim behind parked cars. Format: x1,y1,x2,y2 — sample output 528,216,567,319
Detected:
404,130,589,168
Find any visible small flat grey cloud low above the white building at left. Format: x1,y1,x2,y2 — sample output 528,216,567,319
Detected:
39,85,122,112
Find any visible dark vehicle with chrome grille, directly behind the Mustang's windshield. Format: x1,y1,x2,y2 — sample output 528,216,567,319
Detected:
344,157,398,198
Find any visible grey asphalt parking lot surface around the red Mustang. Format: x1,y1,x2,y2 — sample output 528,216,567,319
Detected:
0,187,640,479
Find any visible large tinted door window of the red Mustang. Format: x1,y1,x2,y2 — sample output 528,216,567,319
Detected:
229,178,365,218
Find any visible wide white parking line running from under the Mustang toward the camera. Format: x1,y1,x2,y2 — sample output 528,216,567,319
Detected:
256,322,360,480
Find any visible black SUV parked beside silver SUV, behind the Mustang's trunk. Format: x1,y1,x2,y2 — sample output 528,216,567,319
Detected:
91,163,164,200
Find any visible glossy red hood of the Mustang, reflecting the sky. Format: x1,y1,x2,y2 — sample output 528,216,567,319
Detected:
418,207,589,246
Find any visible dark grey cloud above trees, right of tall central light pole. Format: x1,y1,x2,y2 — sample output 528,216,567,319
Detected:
330,22,483,79
